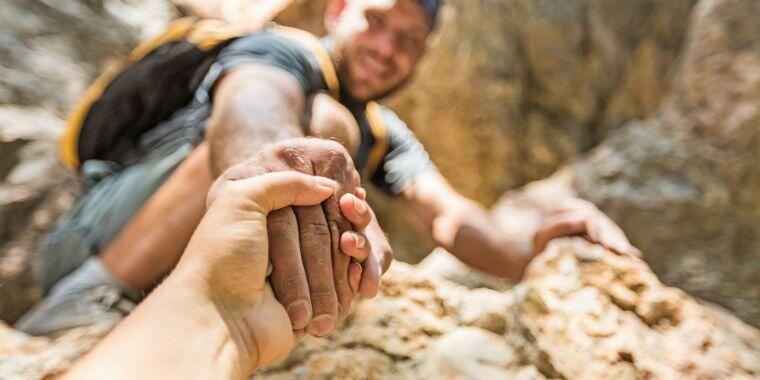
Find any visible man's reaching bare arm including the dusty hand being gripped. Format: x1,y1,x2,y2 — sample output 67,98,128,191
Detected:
208,63,387,336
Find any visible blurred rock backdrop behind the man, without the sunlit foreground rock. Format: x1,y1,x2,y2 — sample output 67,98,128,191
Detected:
0,0,760,378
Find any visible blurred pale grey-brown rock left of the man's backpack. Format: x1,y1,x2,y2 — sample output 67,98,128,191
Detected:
0,0,178,321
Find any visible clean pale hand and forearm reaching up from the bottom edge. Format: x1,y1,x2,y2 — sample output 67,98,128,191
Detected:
67,171,337,379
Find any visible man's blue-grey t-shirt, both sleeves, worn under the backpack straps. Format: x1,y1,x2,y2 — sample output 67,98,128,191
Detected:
143,29,437,195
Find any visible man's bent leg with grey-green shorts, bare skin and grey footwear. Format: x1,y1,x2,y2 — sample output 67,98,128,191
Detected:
15,145,211,335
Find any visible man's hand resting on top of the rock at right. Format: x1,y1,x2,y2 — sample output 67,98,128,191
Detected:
533,199,643,258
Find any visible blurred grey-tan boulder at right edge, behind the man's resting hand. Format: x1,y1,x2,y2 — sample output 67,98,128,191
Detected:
497,1,760,326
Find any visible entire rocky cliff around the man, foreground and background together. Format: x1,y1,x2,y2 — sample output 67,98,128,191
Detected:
0,0,760,378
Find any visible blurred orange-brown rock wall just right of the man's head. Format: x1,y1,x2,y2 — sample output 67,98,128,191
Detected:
382,0,694,203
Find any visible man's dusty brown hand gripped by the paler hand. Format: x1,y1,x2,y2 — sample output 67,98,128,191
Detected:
206,138,387,336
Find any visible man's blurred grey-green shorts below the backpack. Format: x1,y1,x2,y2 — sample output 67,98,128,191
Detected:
35,143,194,293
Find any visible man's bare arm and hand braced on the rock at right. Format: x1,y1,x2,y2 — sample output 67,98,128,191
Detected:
403,171,641,281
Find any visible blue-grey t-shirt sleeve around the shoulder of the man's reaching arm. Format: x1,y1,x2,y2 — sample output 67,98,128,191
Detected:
191,30,326,100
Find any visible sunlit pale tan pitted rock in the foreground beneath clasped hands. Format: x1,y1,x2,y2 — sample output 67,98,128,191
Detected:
0,238,760,379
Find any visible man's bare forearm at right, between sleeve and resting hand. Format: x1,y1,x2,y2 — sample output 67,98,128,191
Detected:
402,171,530,281
